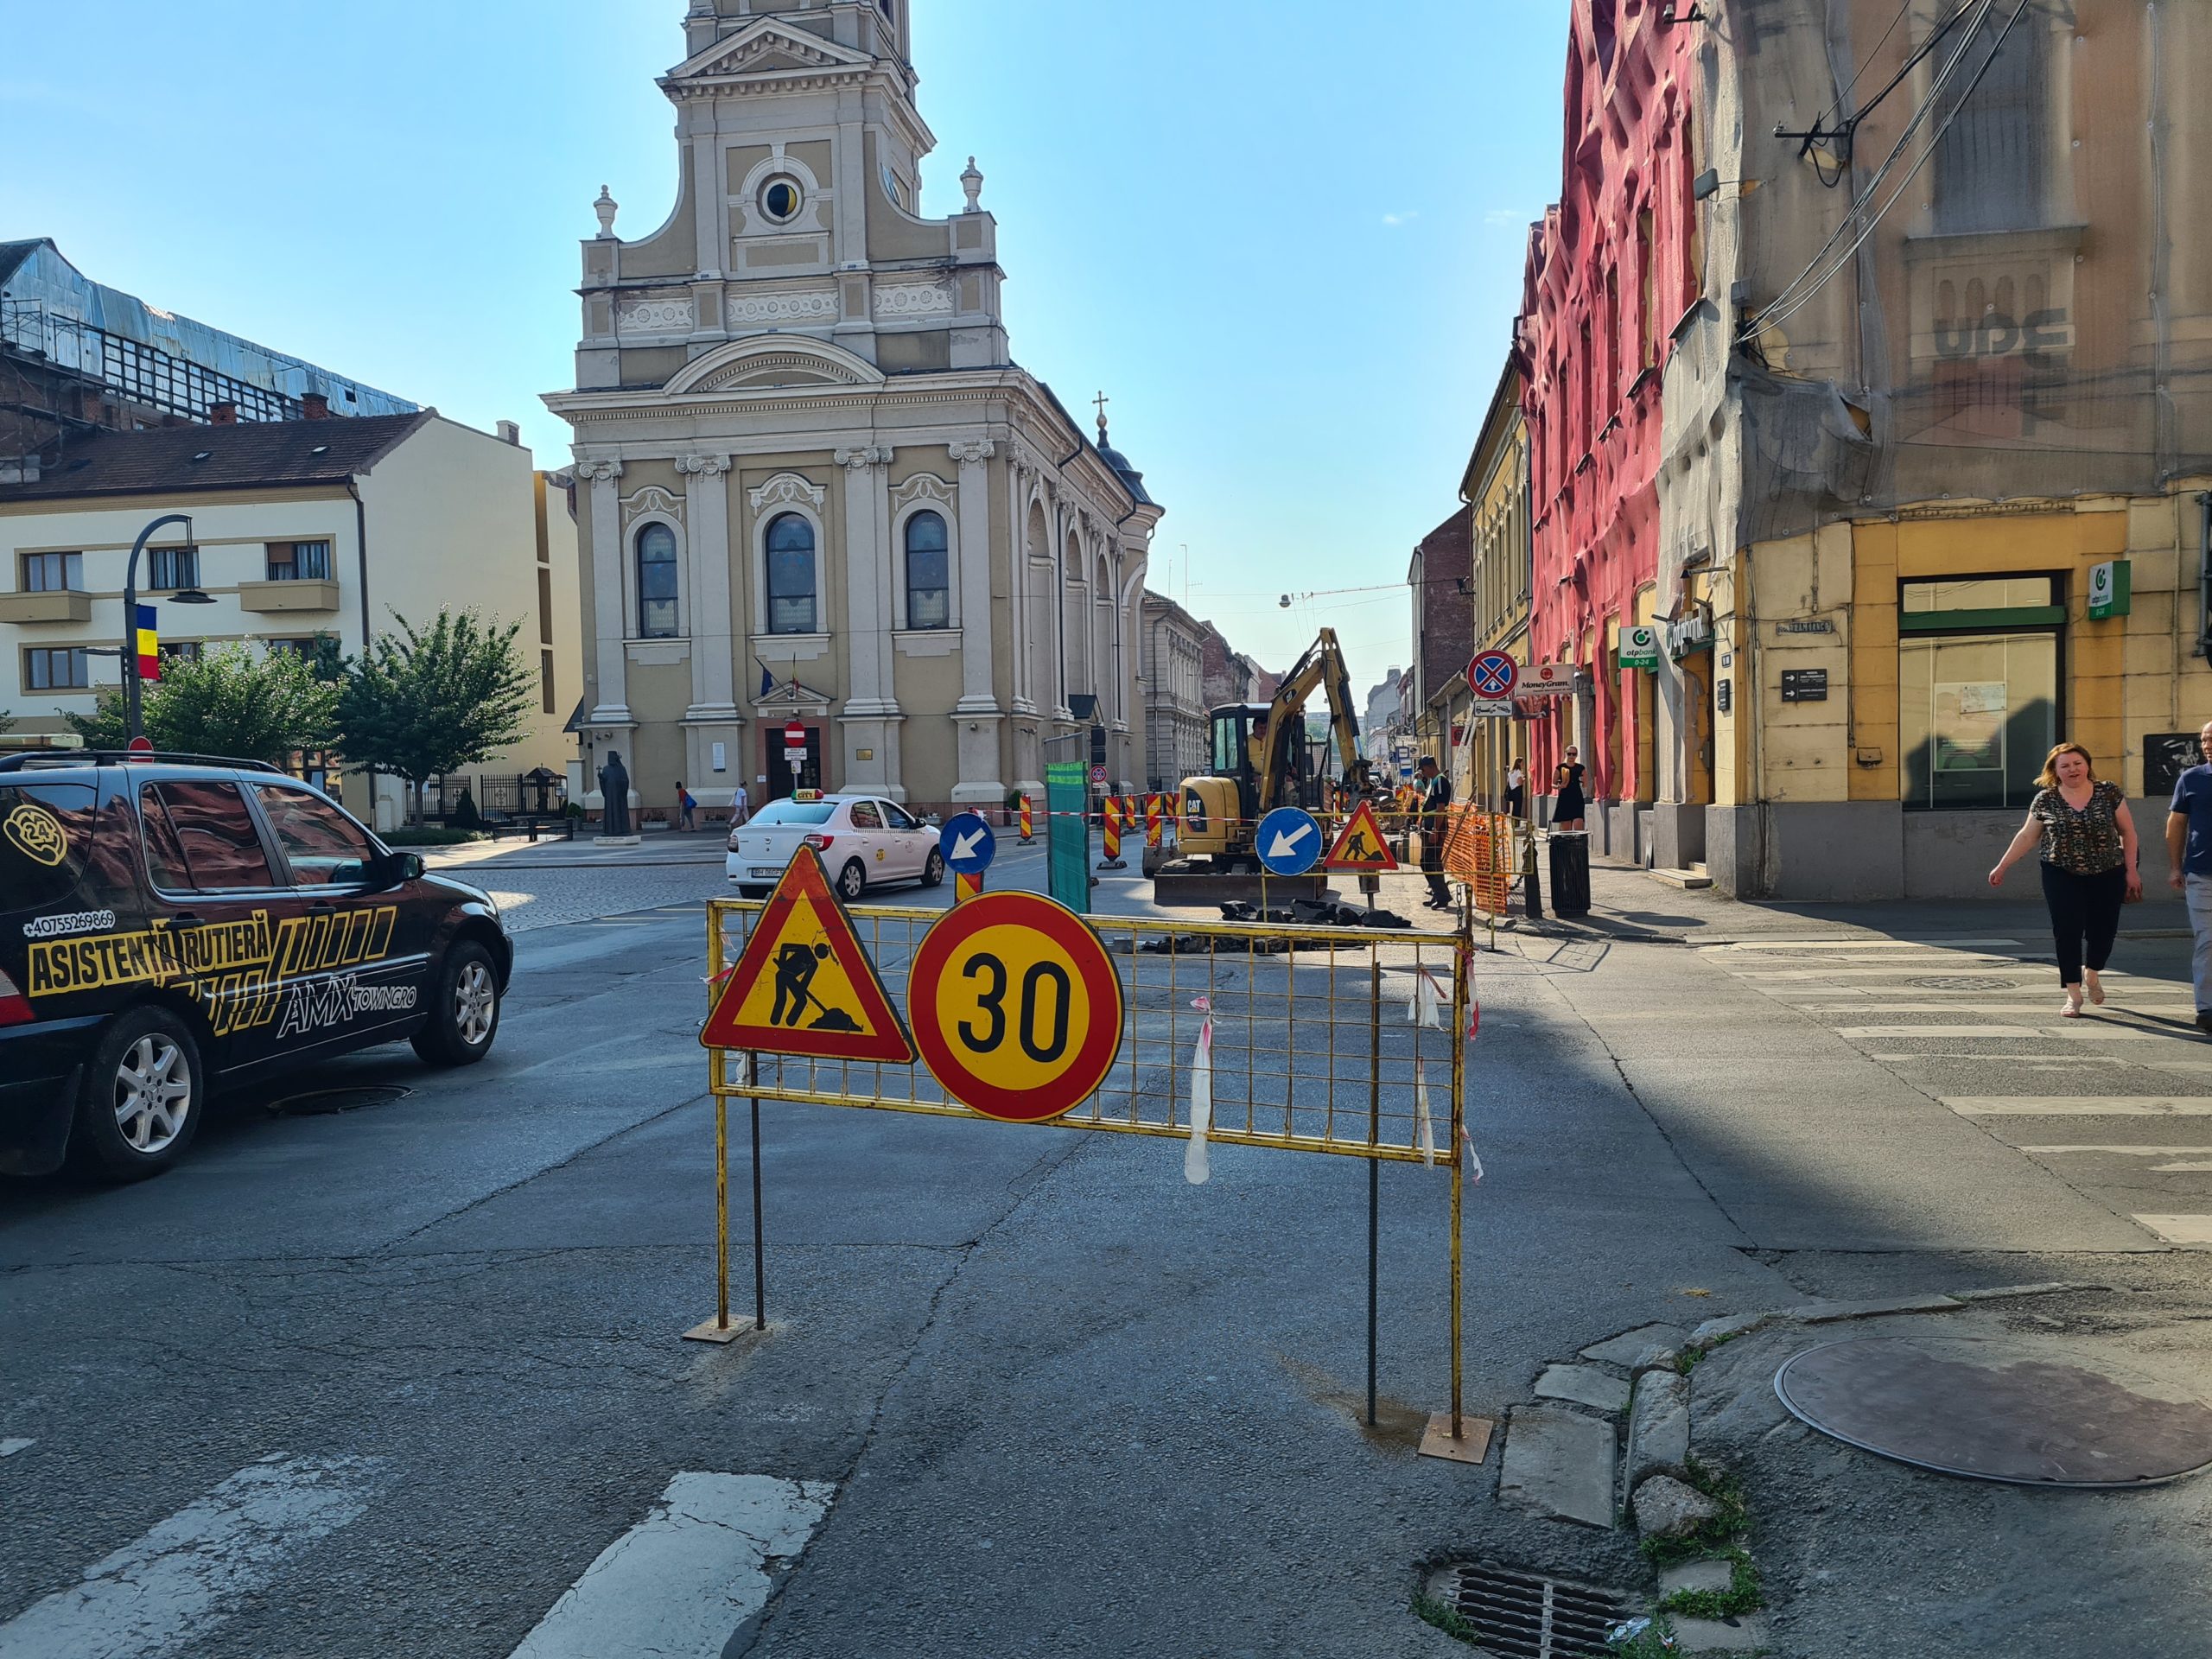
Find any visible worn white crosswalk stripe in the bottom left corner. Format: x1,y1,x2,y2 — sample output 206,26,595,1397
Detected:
0,1455,378,1659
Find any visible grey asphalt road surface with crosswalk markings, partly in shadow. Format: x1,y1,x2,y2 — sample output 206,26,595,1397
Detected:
0,854,2212,1659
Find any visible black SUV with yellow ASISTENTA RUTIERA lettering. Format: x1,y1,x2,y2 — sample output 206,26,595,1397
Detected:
0,750,513,1179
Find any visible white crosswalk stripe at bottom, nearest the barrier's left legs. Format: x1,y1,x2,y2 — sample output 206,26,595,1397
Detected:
513,1473,836,1659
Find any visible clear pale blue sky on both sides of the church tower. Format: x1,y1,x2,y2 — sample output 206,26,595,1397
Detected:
17,0,1566,688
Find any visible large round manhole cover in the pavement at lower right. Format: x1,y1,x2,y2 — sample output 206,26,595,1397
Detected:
1774,1336,2212,1486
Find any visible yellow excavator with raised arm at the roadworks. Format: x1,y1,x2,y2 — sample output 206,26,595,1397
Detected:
1146,628,1371,876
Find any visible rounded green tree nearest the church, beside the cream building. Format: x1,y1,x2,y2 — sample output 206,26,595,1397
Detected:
339,611,537,823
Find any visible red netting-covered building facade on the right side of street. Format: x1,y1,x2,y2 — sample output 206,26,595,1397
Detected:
1513,0,1701,836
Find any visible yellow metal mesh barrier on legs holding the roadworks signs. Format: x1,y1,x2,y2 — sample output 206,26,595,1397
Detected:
692,898,1489,1462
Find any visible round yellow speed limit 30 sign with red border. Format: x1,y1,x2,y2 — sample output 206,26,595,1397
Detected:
907,892,1122,1123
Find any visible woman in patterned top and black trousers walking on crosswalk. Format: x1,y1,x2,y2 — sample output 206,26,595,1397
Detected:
1988,743,2141,1020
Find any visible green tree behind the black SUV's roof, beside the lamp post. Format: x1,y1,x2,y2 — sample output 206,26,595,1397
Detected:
62,644,339,766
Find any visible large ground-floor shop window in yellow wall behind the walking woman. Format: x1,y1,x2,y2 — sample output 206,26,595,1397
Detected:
1897,575,2066,810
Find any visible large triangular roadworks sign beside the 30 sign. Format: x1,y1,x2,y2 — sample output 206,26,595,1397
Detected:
699,847,913,1066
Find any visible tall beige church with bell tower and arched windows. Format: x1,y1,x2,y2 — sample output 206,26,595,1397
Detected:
546,0,1161,812
